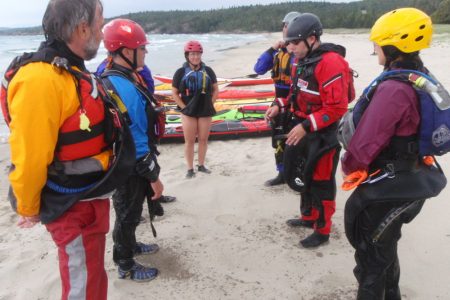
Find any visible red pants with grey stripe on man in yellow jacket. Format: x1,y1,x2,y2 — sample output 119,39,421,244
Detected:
46,199,109,300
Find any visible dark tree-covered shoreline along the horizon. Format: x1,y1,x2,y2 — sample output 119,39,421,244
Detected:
0,0,450,35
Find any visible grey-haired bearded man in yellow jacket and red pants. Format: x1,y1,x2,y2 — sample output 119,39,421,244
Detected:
2,0,134,299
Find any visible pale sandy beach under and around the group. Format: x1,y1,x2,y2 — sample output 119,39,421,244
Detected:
0,33,450,300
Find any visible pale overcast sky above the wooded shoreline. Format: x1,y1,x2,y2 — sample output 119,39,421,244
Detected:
0,0,355,27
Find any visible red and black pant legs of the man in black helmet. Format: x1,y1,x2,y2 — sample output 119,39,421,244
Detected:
300,149,339,234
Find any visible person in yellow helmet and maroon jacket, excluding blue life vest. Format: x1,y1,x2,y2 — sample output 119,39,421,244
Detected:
342,8,446,300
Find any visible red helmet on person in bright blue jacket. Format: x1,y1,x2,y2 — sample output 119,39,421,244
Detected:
103,19,149,52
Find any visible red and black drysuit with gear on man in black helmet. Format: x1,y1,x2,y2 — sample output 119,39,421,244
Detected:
285,44,352,235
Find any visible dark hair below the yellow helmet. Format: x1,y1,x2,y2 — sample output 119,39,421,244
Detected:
381,46,423,70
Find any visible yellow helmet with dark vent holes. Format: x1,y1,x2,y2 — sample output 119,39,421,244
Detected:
370,7,433,53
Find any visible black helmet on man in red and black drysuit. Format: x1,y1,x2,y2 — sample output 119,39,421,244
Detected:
284,13,322,42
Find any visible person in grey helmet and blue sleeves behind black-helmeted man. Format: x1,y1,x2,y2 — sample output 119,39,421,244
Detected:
254,11,300,186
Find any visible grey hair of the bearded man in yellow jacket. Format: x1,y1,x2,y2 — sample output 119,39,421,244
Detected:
42,0,103,43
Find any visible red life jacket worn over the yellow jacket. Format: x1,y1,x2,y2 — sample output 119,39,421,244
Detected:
0,52,112,161
